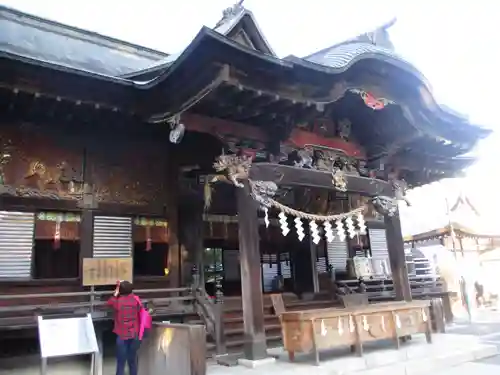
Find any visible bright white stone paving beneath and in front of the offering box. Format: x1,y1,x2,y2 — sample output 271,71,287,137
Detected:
211,334,498,375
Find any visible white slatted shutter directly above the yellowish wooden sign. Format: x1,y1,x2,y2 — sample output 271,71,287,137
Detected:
93,216,132,258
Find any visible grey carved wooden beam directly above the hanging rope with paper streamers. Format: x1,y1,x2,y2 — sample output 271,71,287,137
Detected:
250,163,394,197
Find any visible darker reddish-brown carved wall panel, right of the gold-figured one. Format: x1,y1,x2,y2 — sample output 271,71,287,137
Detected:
88,139,167,205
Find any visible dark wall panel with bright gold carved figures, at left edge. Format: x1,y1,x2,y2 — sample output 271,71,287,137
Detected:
0,126,84,199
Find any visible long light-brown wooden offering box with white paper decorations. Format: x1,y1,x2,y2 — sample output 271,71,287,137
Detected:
280,301,431,364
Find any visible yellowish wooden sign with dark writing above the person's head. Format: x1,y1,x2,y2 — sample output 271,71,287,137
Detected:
82,258,133,286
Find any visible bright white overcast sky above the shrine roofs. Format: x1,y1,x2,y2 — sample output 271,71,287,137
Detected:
0,0,500,232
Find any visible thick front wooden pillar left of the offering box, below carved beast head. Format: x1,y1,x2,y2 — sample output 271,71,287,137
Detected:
236,181,267,360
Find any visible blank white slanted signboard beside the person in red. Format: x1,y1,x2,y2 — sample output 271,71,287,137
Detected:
38,314,99,359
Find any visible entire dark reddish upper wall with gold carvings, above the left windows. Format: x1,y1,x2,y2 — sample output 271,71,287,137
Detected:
0,126,168,210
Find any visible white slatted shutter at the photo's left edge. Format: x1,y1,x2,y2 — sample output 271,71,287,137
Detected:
0,211,35,278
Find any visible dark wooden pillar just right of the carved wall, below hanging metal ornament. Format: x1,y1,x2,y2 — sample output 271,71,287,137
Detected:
165,150,182,288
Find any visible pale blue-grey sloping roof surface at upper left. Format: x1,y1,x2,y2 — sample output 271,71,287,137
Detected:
0,6,168,77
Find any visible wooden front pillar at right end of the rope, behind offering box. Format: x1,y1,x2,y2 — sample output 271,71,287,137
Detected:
384,212,412,301
